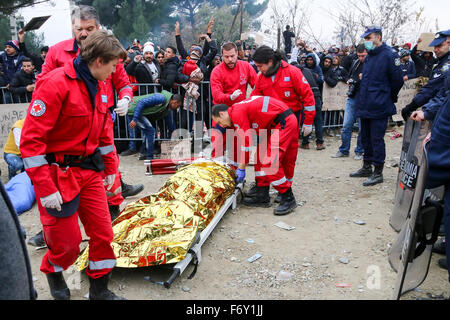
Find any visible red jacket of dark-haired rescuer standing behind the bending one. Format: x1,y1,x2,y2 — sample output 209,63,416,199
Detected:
252,61,316,125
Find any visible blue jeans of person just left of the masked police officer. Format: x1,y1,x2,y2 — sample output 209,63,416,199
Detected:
339,98,364,155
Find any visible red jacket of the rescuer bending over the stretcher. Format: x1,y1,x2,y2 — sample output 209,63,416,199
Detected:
228,96,289,163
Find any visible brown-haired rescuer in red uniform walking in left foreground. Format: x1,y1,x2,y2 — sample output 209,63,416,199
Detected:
20,30,126,300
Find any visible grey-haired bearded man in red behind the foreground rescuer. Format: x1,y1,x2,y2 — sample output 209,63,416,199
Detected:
28,5,144,246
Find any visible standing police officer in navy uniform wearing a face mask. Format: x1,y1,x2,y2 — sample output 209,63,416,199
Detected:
350,27,403,186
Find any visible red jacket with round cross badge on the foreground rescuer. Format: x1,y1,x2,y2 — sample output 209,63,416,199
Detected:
20,63,118,202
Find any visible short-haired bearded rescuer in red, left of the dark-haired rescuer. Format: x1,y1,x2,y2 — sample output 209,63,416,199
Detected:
210,42,257,160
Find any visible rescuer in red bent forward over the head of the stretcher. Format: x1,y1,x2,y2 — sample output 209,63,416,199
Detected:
212,96,298,215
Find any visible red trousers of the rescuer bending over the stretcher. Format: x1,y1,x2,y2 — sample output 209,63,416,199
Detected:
255,114,299,193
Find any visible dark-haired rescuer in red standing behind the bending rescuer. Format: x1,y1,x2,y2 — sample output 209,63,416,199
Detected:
246,46,316,203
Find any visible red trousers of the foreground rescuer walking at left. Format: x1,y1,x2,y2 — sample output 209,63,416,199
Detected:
37,168,116,279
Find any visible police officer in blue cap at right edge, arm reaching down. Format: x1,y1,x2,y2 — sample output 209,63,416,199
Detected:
402,30,450,121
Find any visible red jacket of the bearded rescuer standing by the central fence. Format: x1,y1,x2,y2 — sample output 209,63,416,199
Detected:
210,60,257,106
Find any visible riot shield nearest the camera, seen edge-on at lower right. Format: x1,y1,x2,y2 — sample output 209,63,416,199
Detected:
389,131,443,299
